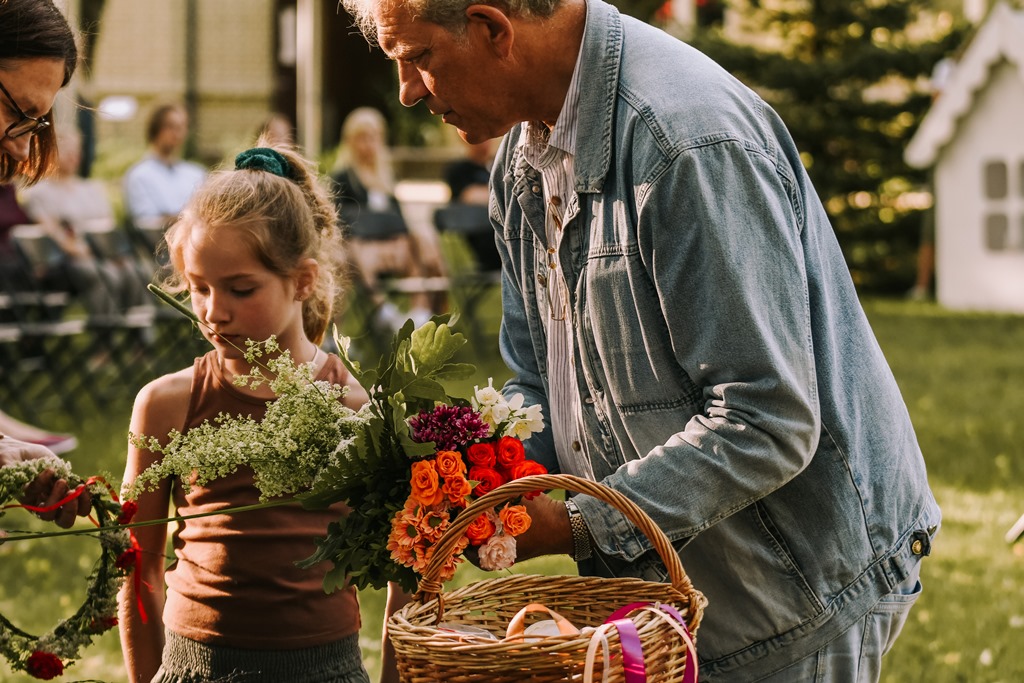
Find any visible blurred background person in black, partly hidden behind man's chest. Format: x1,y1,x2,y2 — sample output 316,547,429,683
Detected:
437,137,502,270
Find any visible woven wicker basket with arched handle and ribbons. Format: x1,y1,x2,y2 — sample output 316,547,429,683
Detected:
388,474,707,683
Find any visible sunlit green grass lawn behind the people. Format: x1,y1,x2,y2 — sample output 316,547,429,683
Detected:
0,300,1024,683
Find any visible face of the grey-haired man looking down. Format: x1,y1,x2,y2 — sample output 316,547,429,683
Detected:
376,2,521,142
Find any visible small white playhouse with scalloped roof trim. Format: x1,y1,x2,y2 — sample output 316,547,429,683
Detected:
905,3,1024,312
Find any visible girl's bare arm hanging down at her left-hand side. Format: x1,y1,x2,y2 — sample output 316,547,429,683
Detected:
118,368,191,683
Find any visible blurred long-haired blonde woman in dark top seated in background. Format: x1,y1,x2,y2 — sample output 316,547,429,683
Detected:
331,106,443,330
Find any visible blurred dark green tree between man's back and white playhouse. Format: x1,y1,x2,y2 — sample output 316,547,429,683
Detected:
689,0,967,292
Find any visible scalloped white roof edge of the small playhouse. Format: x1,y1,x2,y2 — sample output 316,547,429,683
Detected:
903,2,1024,168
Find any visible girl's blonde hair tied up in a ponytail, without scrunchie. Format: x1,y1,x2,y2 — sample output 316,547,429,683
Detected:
165,136,342,344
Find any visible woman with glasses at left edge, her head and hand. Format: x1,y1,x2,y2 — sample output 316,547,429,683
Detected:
0,0,89,528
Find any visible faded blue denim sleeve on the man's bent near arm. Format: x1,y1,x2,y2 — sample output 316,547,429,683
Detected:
580,139,820,560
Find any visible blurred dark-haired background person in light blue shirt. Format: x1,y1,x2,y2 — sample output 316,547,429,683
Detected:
124,104,206,235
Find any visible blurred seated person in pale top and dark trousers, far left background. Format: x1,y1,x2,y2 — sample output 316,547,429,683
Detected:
23,130,150,316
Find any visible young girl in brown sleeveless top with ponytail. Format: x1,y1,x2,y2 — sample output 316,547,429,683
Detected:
120,139,369,683
